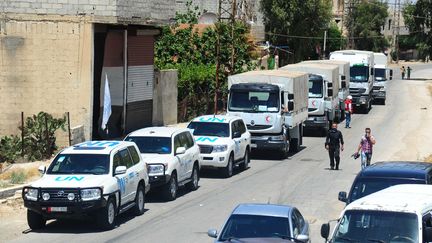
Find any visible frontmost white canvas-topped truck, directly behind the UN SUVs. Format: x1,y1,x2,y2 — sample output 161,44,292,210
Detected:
227,70,308,158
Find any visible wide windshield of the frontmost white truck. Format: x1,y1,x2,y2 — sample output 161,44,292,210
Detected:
228,90,281,112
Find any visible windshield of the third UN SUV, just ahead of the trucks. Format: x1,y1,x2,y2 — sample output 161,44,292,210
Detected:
188,122,230,137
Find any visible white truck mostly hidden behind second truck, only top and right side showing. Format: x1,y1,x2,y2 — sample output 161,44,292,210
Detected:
302,60,350,121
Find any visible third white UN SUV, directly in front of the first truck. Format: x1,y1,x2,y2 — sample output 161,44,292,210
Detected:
188,115,251,177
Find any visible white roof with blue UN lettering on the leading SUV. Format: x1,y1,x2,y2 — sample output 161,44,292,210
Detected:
61,141,134,154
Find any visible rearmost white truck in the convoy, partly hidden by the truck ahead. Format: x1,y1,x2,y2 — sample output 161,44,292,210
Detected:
373,52,393,105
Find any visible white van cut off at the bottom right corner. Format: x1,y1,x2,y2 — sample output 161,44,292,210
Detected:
321,184,432,243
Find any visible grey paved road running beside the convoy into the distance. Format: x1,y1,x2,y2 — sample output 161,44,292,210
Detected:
9,66,432,243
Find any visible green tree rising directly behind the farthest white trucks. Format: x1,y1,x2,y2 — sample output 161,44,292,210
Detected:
345,0,389,52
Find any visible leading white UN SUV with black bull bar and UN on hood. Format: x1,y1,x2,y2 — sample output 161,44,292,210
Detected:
22,141,150,229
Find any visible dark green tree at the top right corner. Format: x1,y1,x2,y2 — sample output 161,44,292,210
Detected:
403,0,432,60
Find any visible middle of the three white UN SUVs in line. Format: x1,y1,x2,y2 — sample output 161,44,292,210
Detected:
125,127,201,201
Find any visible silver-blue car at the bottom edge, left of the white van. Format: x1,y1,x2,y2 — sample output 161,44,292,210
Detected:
208,204,309,242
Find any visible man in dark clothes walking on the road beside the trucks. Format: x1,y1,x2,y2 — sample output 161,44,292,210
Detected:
325,122,344,170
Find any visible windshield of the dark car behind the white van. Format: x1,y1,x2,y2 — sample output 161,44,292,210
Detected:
349,177,425,202
